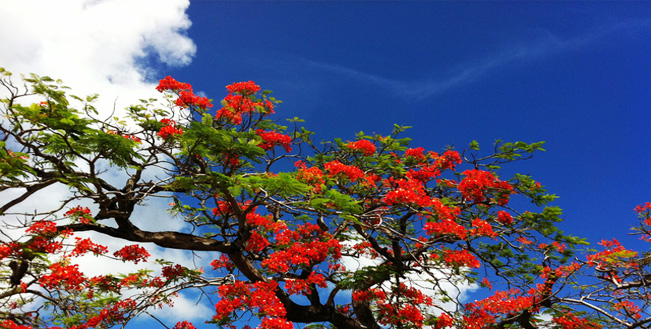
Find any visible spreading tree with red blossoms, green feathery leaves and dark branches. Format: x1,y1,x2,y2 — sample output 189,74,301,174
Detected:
0,70,651,329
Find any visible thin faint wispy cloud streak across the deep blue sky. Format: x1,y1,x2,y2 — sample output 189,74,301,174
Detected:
301,19,651,101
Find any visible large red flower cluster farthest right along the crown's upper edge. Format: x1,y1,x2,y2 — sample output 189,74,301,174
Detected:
458,169,513,205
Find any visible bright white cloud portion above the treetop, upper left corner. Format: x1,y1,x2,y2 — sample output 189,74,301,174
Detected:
0,0,196,114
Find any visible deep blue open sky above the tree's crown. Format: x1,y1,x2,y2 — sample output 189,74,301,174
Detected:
159,1,651,249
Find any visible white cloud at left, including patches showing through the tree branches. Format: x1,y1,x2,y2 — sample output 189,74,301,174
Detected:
0,0,211,318
